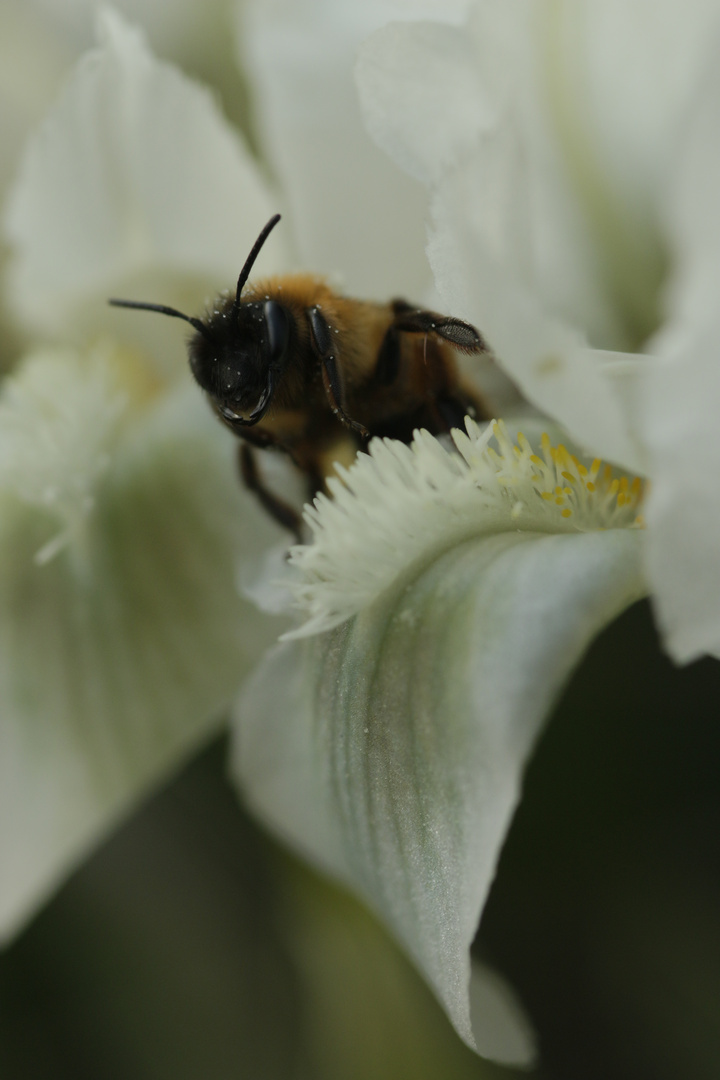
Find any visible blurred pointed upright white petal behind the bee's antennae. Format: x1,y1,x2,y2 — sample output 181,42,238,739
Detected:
5,9,283,337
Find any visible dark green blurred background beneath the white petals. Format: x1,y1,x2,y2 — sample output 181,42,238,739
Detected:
0,605,720,1080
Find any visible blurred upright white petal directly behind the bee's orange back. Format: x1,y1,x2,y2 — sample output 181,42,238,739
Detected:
239,0,432,300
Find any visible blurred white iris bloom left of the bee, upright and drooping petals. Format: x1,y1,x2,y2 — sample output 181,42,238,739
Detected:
0,11,287,935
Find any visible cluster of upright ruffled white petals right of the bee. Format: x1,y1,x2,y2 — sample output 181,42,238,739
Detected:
358,0,720,661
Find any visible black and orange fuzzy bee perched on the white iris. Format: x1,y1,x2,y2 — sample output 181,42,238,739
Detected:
109,214,487,538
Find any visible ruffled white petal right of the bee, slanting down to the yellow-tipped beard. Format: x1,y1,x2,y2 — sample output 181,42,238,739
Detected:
358,11,641,471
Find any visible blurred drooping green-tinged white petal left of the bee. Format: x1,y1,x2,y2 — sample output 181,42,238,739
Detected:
0,354,282,936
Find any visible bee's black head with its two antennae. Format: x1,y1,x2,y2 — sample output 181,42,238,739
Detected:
109,214,290,426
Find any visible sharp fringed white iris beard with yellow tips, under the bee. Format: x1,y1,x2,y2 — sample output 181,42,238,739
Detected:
286,418,643,637
